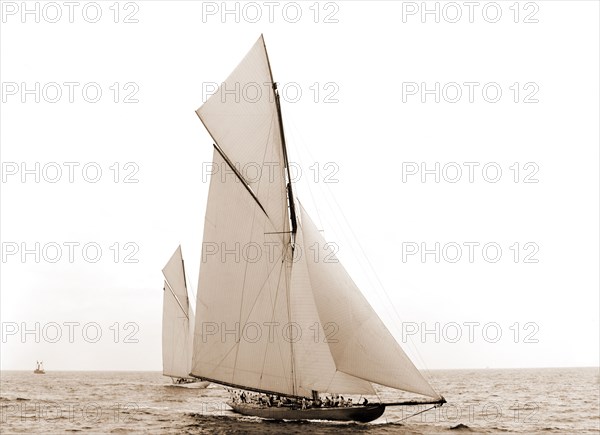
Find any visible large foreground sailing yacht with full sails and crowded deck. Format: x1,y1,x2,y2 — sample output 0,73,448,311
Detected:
191,36,445,422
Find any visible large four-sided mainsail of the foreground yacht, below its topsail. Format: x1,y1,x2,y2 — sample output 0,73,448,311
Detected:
192,150,296,395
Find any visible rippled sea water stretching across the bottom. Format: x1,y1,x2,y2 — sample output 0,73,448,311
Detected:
0,368,600,435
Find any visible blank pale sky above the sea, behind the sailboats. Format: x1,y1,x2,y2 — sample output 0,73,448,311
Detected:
0,1,600,371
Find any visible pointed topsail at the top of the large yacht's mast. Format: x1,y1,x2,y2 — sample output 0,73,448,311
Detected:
196,36,288,231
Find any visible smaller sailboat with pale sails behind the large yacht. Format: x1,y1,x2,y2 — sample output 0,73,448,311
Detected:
162,246,209,387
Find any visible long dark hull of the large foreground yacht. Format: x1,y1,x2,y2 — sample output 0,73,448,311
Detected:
228,402,385,423
